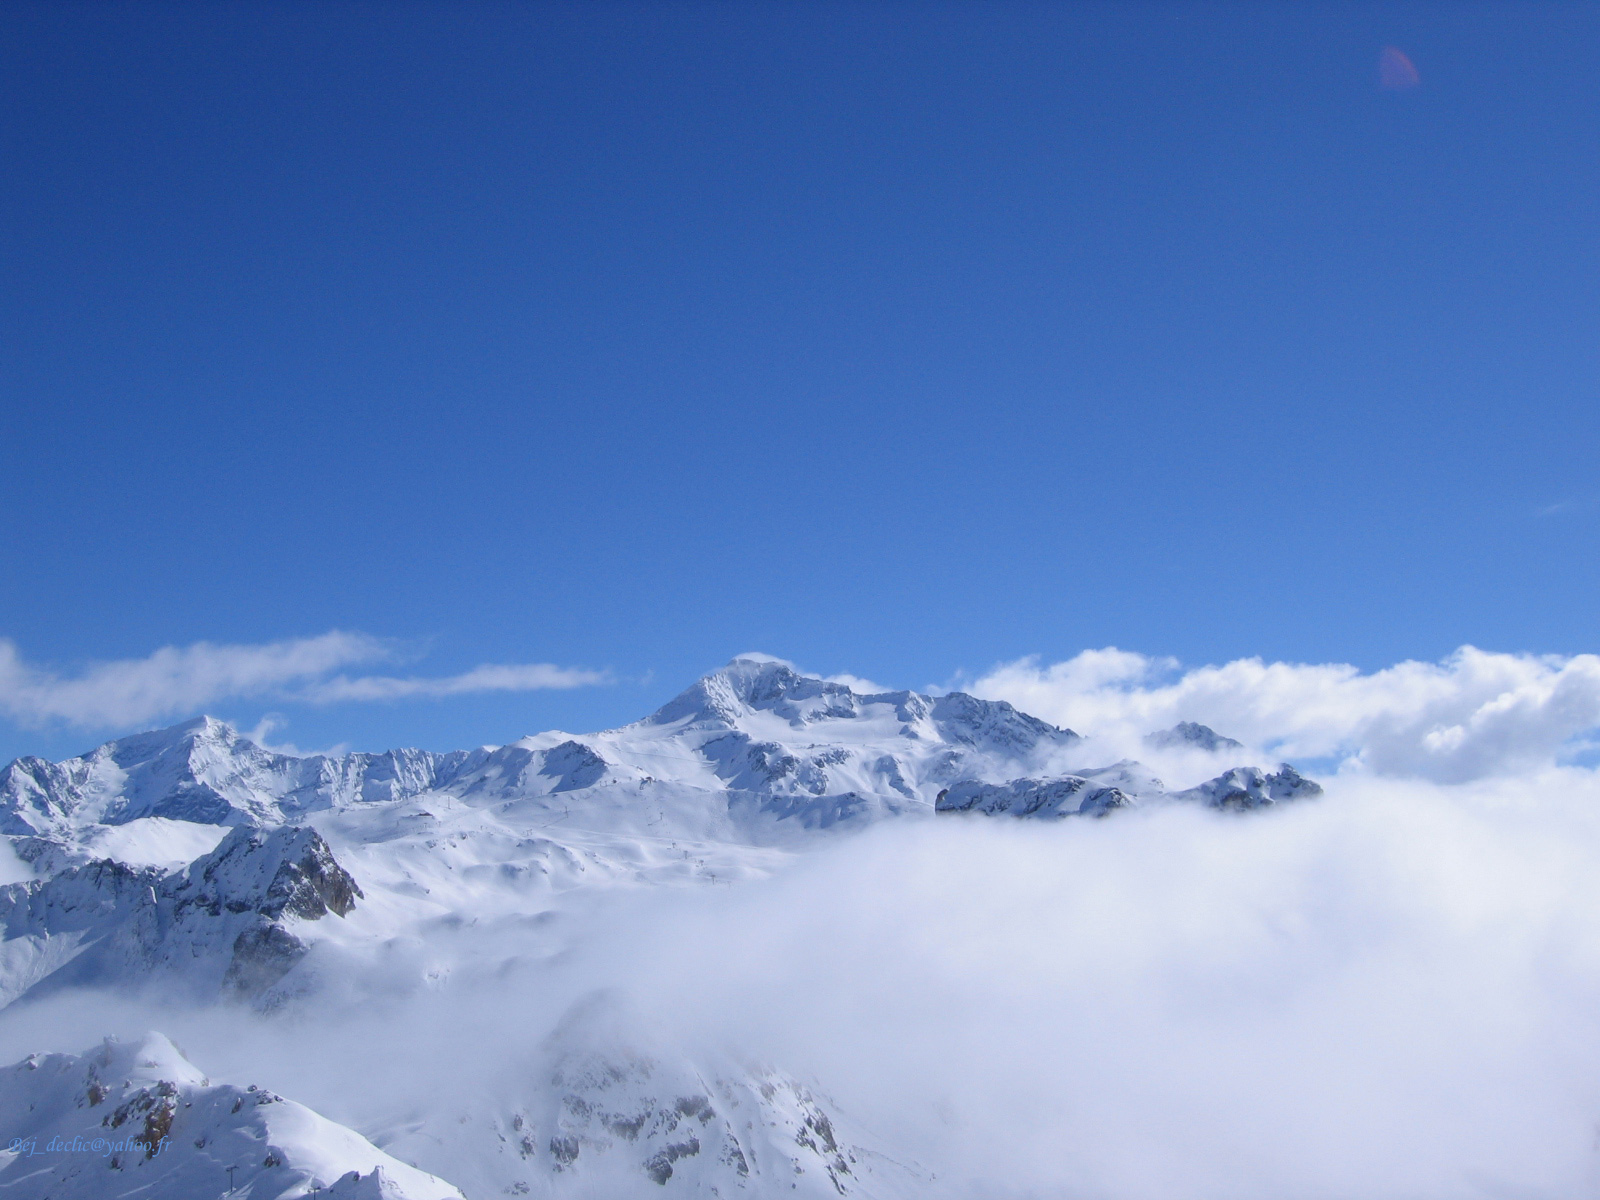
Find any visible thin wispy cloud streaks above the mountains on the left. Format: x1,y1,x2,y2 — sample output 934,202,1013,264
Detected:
0,630,606,728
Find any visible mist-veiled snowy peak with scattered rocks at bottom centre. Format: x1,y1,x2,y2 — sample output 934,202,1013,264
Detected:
373,994,931,1200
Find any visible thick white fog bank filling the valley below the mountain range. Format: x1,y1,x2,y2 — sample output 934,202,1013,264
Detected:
18,771,1600,1200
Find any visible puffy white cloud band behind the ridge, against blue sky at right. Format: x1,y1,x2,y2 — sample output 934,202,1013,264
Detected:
971,646,1600,782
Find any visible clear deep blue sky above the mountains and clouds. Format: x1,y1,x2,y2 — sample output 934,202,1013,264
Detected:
0,3,1600,757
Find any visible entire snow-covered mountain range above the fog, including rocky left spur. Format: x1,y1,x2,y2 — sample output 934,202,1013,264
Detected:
0,658,1318,1006
